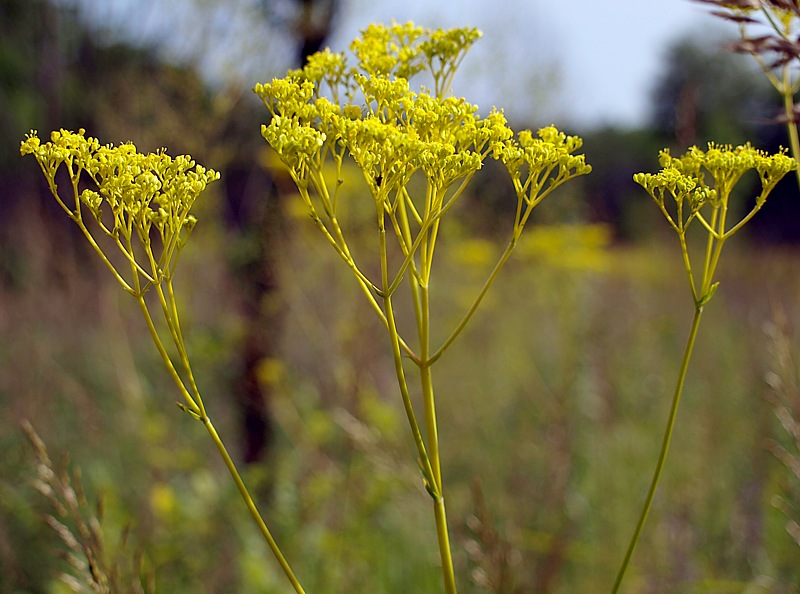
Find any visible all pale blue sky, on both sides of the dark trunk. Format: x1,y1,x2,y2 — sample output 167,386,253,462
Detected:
70,0,735,129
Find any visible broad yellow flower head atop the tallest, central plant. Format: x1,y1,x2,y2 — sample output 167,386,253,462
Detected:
255,23,591,215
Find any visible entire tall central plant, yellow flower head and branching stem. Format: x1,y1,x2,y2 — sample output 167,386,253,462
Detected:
255,23,591,594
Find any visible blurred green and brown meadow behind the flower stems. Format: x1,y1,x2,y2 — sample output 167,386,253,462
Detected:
0,196,800,594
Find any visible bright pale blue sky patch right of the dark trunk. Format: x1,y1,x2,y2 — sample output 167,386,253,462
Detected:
331,0,735,127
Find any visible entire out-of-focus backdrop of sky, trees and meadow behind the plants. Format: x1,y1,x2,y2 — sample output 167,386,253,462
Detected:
0,0,800,594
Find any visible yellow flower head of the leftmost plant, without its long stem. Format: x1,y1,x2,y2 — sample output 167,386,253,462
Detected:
20,129,219,291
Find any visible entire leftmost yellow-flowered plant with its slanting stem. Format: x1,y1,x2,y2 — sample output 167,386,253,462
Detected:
20,130,304,594
